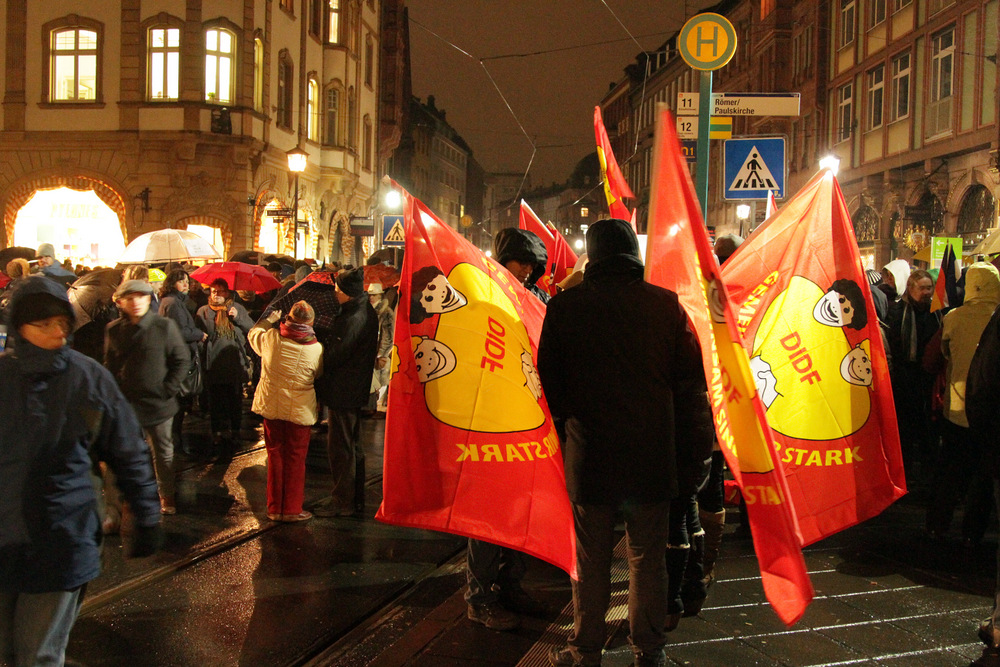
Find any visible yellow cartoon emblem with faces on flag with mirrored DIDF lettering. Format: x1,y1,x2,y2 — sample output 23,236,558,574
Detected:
410,263,545,433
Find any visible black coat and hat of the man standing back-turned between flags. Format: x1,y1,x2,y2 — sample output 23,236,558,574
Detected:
538,220,713,505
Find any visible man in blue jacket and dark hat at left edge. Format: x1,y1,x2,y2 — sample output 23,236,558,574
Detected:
0,276,163,665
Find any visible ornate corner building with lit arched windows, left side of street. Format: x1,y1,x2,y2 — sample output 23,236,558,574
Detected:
0,0,406,264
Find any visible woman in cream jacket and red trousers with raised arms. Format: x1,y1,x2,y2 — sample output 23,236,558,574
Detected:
247,301,323,522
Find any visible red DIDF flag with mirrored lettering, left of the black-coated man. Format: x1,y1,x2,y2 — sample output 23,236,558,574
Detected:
376,186,576,575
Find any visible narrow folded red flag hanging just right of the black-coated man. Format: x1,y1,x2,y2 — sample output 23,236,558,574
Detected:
646,109,813,625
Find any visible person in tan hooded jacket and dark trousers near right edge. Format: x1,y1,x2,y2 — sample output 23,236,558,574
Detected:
927,262,1000,545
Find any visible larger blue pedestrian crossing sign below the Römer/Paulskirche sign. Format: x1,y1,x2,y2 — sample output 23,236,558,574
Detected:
723,137,785,199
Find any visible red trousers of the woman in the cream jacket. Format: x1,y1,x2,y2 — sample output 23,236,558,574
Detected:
264,419,310,514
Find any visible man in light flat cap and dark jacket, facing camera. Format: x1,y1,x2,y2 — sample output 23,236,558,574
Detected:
104,280,191,514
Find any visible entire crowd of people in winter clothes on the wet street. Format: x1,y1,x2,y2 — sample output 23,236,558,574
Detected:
0,226,1000,666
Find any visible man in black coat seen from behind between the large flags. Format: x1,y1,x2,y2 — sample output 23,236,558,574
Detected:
538,220,713,665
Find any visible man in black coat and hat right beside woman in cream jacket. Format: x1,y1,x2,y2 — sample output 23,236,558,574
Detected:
313,267,378,517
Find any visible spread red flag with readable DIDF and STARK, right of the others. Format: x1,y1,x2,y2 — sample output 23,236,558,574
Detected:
723,170,906,544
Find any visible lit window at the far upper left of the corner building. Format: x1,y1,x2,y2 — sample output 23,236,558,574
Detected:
43,16,104,102
